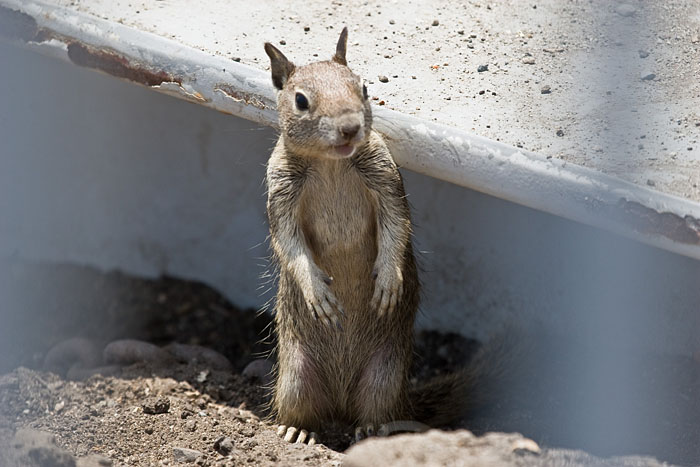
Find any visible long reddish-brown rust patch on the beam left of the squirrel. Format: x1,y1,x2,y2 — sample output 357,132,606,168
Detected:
68,42,182,86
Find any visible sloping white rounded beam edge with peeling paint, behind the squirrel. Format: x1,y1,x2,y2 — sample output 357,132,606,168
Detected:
0,0,700,259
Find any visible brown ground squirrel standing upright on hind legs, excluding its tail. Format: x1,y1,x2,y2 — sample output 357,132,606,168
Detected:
265,28,478,442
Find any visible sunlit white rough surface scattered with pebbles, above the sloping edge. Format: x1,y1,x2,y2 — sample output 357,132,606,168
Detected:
60,0,700,201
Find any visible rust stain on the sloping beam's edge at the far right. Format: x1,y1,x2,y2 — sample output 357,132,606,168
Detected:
617,198,700,245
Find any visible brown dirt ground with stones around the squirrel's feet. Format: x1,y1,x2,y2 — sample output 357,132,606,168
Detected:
0,263,700,467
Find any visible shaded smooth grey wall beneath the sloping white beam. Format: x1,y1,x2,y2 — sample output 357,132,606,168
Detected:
0,45,700,354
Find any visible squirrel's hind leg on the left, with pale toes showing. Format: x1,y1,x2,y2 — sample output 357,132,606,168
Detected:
273,342,329,444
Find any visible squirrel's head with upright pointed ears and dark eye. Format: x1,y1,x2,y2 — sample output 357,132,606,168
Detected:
265,27,372,159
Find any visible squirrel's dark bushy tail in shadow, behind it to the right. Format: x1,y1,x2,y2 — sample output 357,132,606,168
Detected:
409,329,524,427
